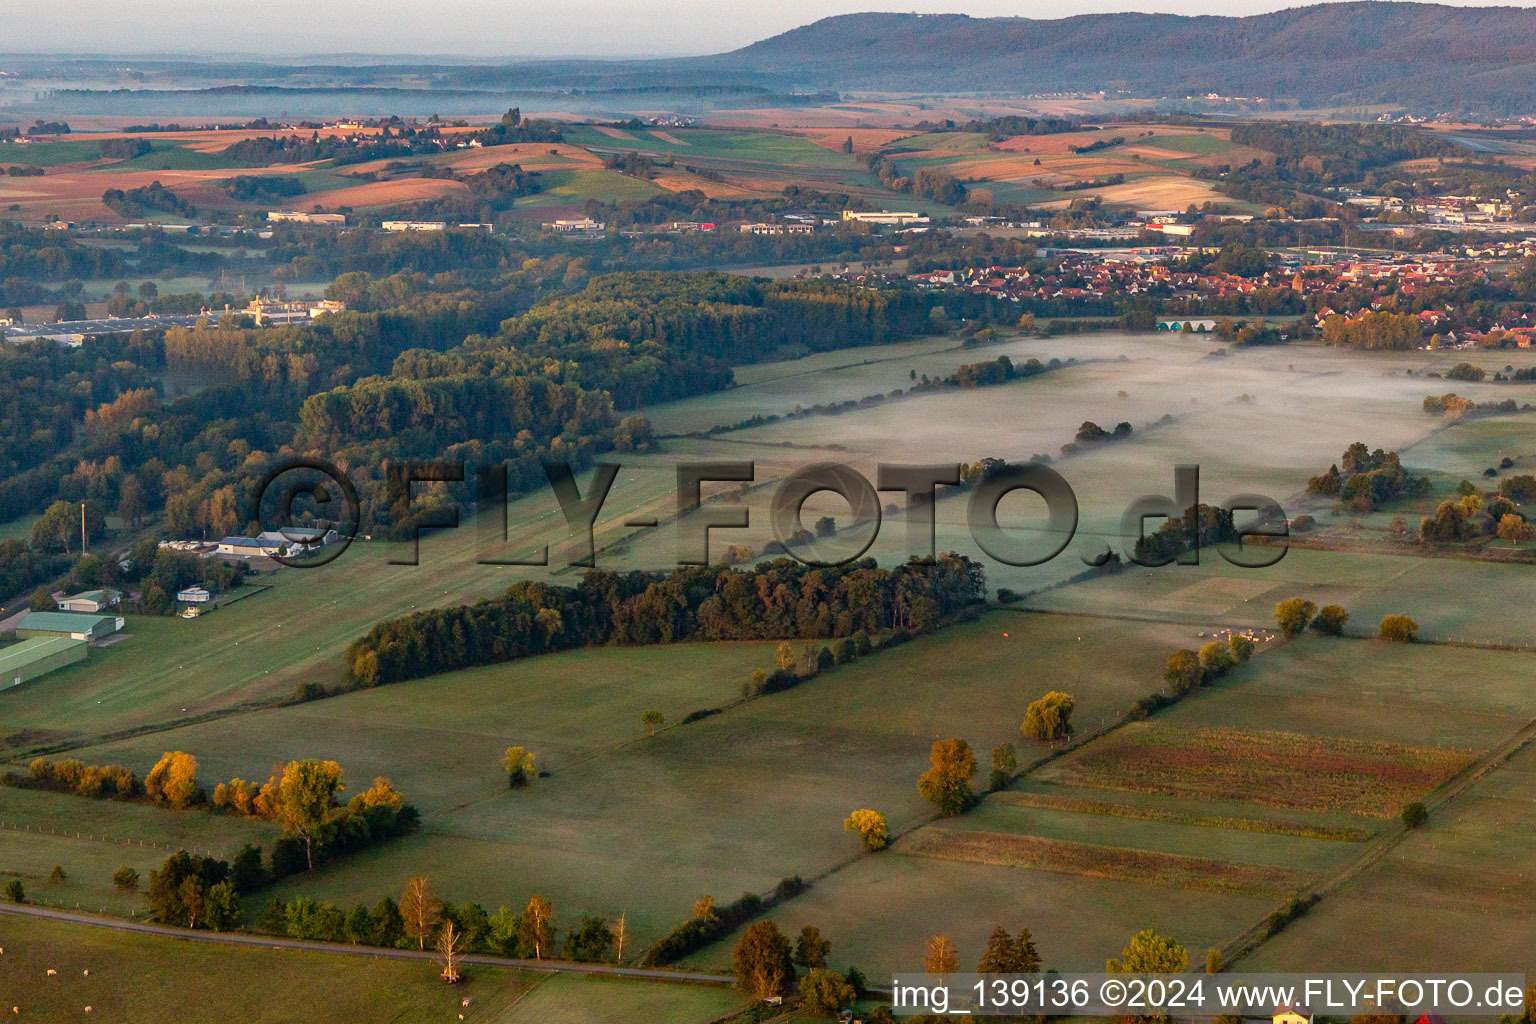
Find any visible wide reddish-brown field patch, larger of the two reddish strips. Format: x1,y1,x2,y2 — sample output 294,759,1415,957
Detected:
1043,723,1475,818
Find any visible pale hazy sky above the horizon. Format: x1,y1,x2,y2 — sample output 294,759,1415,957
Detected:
0,0,1529,58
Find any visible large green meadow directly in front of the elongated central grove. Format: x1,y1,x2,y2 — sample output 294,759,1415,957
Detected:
51,613,1184,941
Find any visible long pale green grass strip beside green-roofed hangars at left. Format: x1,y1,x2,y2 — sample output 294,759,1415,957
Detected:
0,454,691,746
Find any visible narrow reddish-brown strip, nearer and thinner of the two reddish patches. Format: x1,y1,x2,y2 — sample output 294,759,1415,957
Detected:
895,827,1310,898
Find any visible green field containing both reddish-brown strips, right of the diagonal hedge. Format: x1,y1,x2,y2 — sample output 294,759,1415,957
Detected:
697,620,1536,969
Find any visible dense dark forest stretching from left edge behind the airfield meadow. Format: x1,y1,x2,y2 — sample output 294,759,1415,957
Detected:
0,263,931,574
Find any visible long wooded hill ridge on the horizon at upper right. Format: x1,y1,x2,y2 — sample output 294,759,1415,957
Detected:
700,3,1536,112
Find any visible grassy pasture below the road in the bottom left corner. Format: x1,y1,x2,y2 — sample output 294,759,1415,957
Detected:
0,915,546,1024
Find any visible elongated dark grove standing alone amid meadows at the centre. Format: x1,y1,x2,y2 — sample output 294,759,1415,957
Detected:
347,554,985,686
